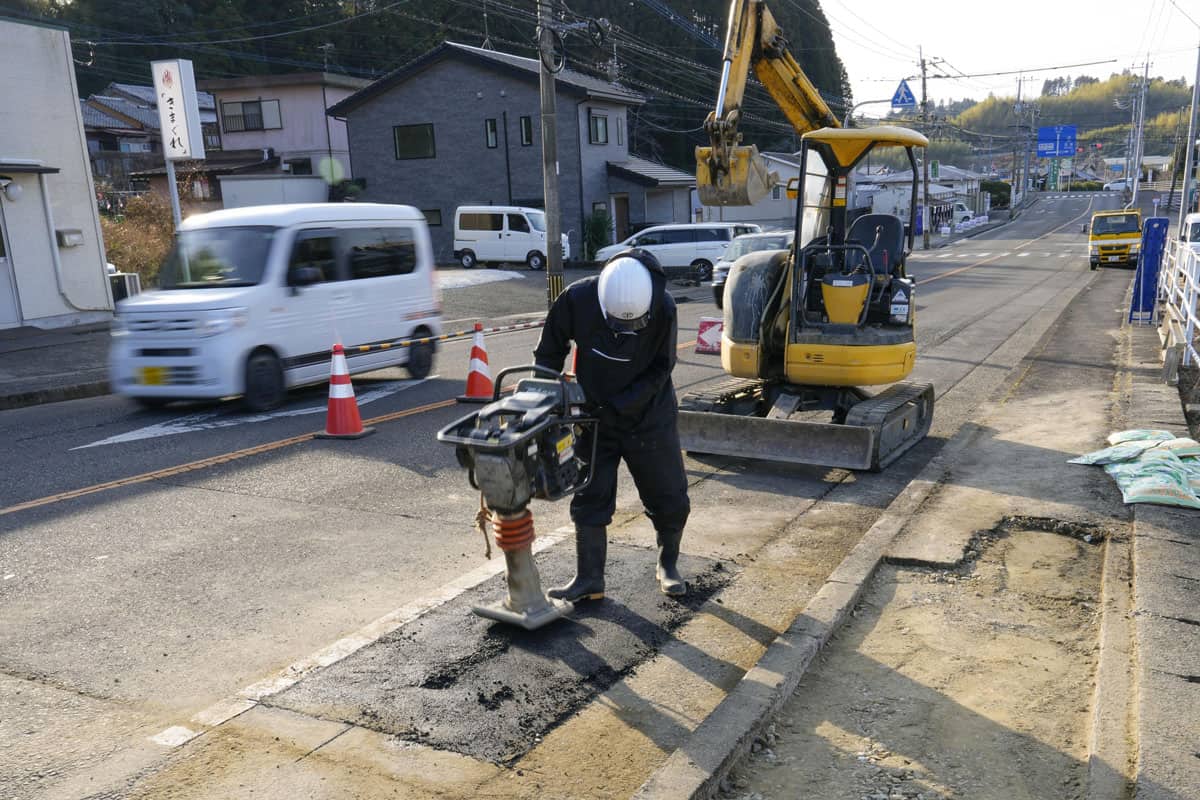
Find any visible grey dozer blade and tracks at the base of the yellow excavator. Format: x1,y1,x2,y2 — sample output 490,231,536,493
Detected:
679,379,934,471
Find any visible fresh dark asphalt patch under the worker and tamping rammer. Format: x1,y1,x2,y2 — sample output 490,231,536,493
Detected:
264,542,734,763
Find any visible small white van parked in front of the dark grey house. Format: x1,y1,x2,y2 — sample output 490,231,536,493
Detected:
454,205,571,270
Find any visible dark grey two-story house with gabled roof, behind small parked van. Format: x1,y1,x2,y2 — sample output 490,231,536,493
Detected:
329,42,696,260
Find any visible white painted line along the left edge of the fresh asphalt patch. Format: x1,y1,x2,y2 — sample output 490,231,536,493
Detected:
150,525,575,747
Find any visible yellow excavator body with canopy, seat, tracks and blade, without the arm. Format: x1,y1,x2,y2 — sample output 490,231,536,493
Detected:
680,126,934,470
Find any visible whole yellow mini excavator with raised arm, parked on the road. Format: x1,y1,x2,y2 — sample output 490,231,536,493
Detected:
679,0,934,470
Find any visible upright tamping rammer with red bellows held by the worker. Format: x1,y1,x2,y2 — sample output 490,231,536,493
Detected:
438,366,598,631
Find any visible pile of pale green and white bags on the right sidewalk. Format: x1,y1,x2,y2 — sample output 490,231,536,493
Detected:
1068,429,1200,509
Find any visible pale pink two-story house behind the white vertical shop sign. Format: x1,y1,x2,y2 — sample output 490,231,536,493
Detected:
196,72,371,184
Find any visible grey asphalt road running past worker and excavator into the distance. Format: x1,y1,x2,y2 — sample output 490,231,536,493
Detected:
0,196,1129,798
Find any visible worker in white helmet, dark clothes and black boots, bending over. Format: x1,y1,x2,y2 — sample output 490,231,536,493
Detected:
534,249,691,602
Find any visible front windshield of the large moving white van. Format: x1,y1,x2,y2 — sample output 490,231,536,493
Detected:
158,227,277,289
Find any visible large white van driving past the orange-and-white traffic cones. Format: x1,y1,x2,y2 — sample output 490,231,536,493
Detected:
109,203,442,410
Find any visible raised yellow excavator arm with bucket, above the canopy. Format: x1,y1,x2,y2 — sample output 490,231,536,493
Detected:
696,0,840,205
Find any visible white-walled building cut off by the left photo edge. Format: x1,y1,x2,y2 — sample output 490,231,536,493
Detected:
0,19,113,329
